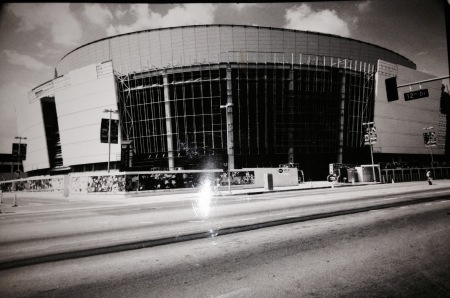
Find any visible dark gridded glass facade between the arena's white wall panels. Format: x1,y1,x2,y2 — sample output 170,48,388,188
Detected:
117,57,374,175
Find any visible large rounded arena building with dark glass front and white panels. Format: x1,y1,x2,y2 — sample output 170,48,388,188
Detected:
18,25,447,179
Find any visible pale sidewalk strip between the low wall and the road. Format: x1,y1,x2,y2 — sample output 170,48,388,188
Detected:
0,180,442,216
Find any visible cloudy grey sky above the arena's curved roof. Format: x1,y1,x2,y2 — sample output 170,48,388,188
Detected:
0,0,450,153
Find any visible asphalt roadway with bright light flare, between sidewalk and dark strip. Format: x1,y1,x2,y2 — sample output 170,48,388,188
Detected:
0,184,450,268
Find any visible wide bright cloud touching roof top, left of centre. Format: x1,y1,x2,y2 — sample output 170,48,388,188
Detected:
107,4,217,36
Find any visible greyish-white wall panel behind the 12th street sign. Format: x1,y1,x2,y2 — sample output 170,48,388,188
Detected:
374,60,445,154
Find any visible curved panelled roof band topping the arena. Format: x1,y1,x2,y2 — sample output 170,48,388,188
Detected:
57,24,416,73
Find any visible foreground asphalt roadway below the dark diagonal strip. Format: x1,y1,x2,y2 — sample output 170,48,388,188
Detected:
0,200,450,297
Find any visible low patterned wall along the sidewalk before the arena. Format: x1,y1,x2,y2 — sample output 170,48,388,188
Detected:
0,168,298,197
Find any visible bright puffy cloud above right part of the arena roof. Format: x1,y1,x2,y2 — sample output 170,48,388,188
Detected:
284,4,350,37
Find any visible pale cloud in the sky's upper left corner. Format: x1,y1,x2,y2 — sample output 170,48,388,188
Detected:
8,3,82,46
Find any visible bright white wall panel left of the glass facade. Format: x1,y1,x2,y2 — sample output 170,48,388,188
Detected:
55,63,120,166
